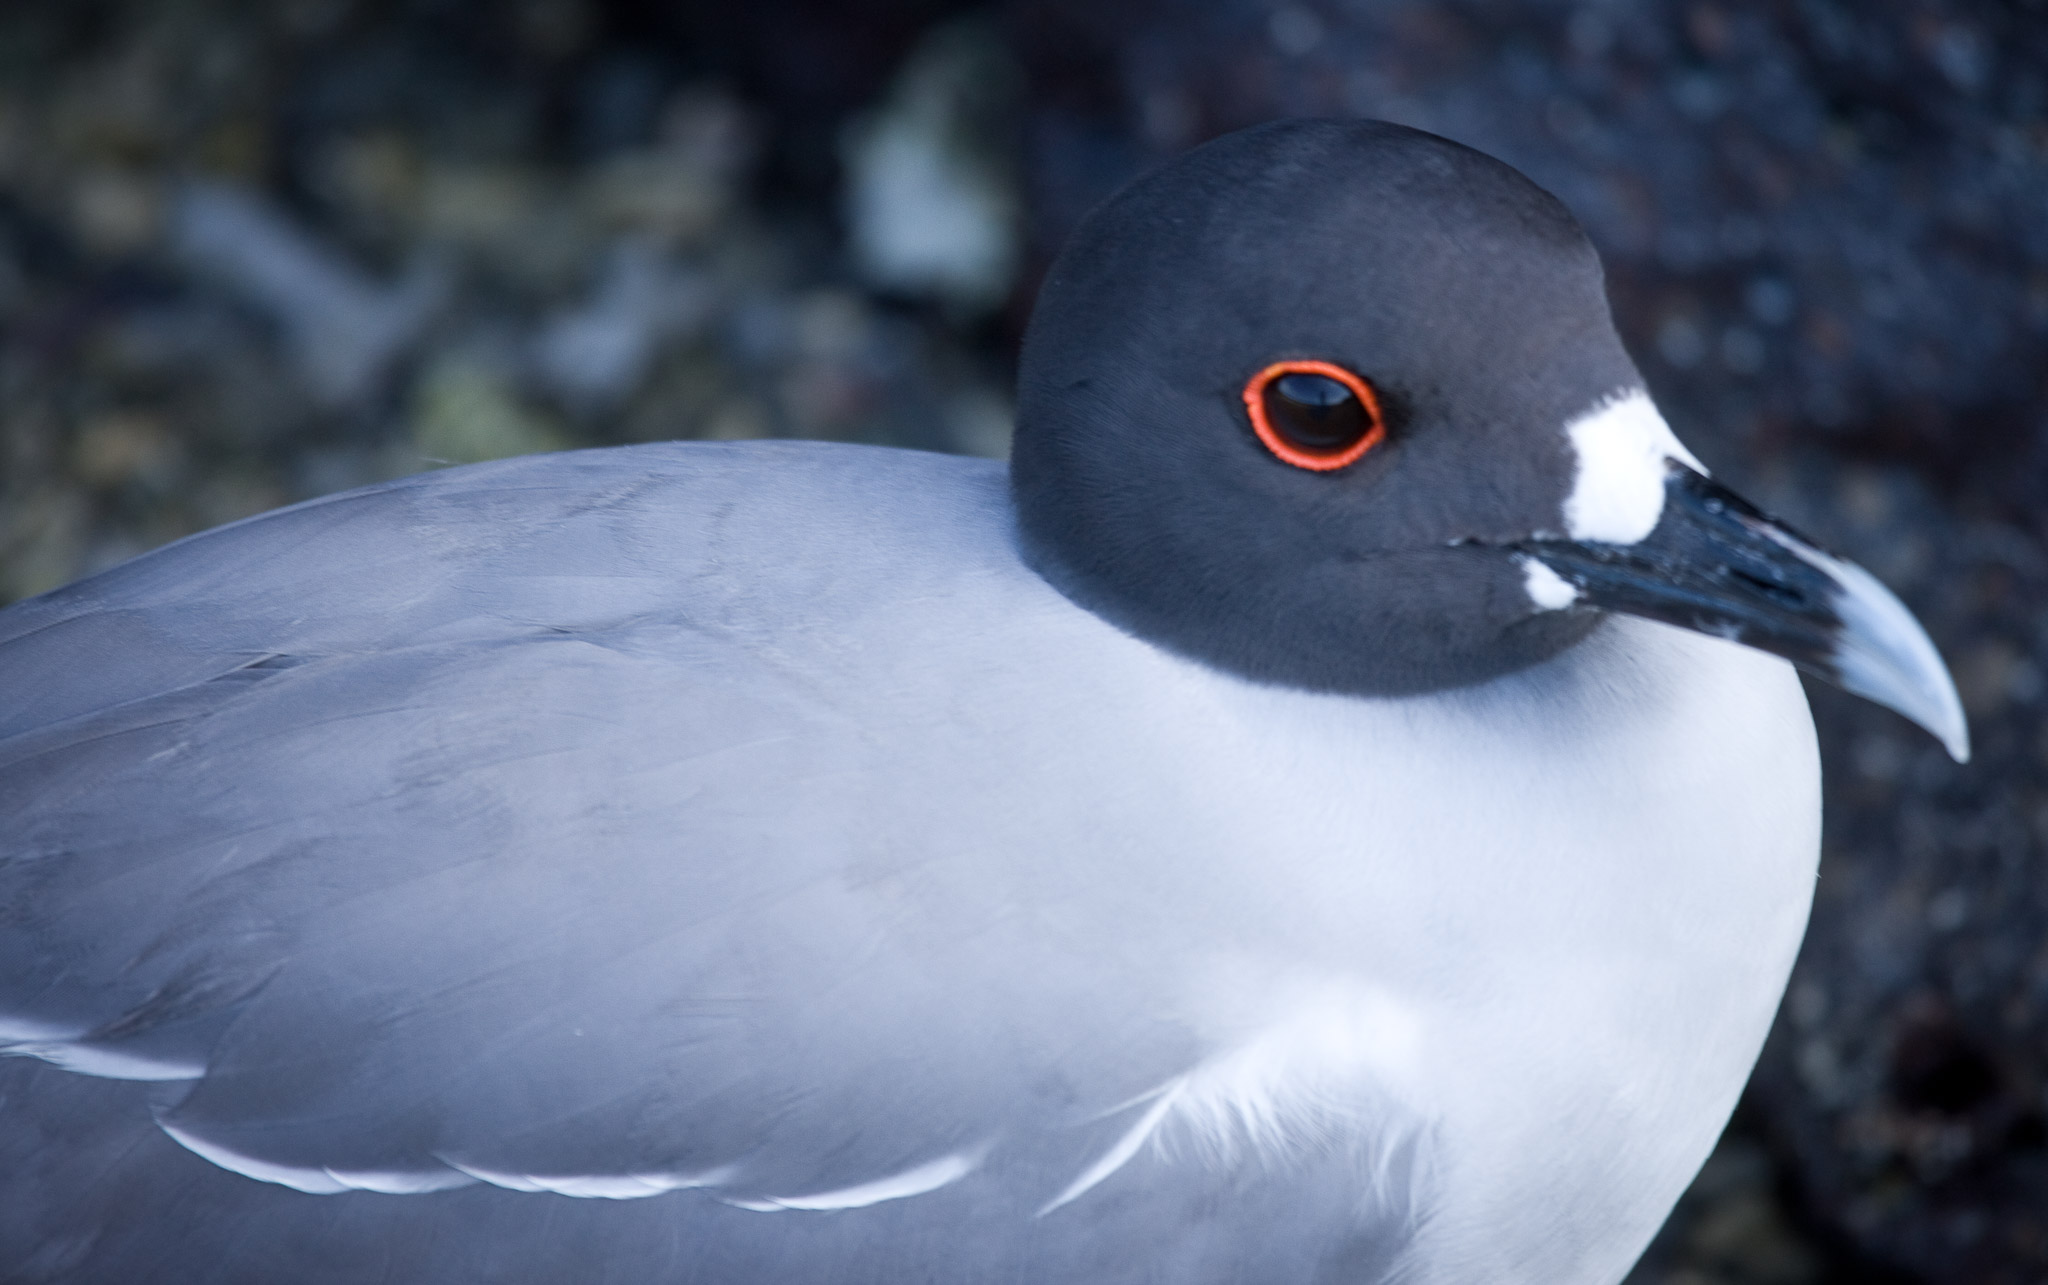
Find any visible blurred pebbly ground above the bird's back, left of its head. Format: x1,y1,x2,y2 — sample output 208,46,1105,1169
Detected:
0,0,1020,598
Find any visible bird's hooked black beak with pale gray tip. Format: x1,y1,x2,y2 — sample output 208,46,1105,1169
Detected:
1516,459,1970,762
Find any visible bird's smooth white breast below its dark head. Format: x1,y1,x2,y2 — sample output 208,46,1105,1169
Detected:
1105,619,1819,1281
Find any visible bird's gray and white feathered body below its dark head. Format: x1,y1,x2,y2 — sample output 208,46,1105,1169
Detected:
4,445,1817,1281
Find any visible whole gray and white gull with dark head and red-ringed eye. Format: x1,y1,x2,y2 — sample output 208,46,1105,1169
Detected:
0,121,1968,1285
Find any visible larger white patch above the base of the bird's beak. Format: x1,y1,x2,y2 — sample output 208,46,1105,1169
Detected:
1556,387,1706,536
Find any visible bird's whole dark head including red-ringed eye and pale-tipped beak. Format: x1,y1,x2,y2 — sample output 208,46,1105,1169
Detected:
1012,121,1960,748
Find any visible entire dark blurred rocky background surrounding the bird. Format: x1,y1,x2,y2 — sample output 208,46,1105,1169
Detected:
0,0,2048,1285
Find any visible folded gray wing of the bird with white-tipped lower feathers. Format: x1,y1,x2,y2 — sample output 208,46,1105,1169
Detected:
0,442,1192,1203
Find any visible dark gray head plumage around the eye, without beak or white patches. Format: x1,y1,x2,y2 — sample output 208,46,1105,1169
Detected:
1014,121,1640,693
